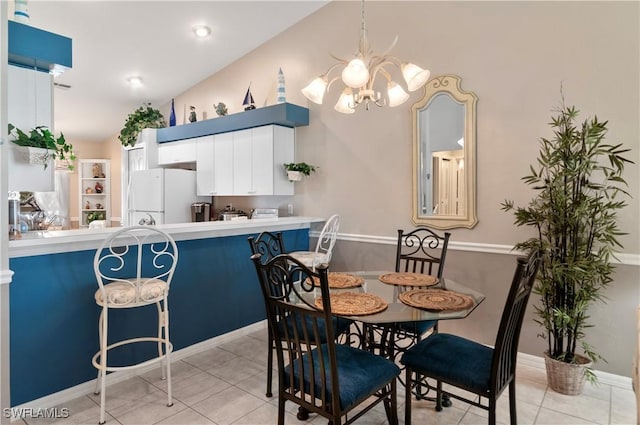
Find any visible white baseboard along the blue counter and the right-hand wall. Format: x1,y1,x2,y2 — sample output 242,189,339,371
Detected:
15,320,632,416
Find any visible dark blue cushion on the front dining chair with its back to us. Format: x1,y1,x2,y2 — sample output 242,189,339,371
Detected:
284,344,400,410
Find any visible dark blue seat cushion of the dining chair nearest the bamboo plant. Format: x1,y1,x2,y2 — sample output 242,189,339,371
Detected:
400,333,493,392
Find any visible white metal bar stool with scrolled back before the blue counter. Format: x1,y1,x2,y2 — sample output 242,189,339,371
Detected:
92,226,178,424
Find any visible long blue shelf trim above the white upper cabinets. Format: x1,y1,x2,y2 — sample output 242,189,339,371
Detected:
157,103,309,143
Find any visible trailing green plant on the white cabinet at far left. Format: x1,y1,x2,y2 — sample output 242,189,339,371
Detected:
9,124,76,171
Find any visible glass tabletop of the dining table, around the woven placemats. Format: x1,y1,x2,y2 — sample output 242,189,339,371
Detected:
320,271,485,325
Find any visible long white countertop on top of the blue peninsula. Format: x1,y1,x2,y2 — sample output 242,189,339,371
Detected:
9,217,325,258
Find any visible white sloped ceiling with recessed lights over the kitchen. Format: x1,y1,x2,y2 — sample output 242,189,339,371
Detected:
20,0,329,143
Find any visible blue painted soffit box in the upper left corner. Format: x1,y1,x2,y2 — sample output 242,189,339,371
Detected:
8,20,72,72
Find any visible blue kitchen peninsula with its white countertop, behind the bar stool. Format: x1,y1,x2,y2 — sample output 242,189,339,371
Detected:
9,217,324,406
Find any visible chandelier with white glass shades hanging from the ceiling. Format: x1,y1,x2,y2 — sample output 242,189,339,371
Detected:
302,0,431,114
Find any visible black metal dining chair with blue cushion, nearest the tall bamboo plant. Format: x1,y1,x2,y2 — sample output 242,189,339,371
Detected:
401,252,539,425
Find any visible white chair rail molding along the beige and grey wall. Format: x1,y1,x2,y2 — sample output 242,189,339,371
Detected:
309,230,640,266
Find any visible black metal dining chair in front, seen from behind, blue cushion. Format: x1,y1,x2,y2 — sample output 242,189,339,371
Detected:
251,254,400,425
